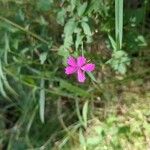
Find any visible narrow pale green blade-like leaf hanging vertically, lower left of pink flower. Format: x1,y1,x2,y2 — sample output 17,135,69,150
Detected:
39,79,45,123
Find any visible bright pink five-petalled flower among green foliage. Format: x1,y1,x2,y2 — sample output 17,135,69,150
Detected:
65,56,95,83
